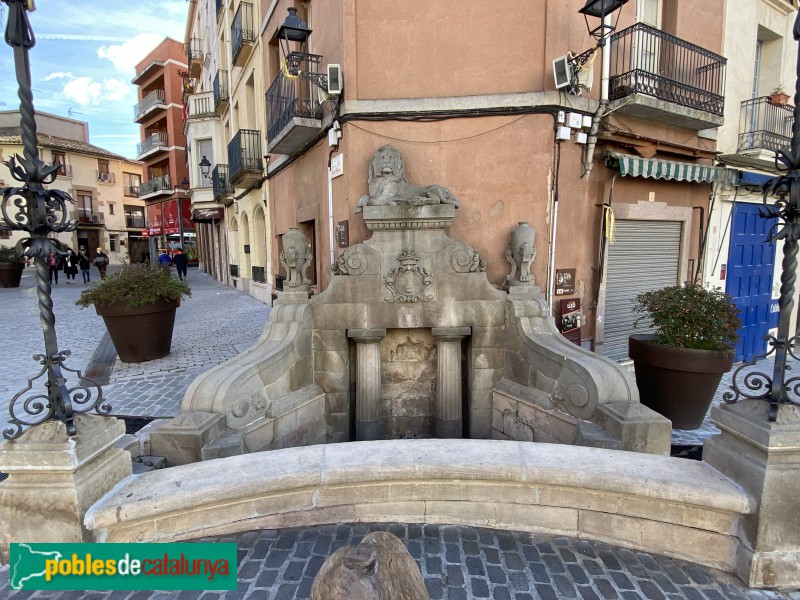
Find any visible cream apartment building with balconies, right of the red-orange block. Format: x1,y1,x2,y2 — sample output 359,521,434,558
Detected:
184,0,272,302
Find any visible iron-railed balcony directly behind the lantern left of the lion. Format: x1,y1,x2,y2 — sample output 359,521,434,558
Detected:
267,52,322,154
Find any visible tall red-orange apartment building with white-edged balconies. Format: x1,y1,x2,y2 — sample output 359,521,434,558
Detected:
132,38,197,262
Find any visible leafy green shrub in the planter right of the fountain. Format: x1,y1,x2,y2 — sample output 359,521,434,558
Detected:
633,285,741,350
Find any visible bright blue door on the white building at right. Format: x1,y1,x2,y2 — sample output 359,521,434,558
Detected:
725,202,776,361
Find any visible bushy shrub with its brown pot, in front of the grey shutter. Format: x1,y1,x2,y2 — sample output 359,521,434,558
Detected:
628,285,741,429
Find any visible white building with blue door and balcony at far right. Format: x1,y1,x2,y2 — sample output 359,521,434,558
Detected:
705,0,797,360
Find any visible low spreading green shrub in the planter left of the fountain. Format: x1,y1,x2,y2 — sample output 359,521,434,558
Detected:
75,265,192,308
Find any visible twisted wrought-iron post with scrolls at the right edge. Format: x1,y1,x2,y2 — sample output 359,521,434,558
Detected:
723,12,800,421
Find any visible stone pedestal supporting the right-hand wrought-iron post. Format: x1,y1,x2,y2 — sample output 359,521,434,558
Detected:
703,400,800,589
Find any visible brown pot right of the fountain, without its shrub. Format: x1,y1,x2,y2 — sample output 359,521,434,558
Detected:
628,334,734,429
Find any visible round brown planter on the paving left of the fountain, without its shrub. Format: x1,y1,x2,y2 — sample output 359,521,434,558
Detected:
95,300,181,363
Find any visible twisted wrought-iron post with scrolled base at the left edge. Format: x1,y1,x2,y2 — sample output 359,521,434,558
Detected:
0,0,111,439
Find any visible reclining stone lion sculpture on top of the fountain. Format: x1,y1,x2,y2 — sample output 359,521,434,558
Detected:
356,144,459,212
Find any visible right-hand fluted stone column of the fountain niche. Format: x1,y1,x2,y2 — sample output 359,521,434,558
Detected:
431,327,472,438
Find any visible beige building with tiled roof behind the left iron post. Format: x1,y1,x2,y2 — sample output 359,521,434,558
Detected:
0,111,147,264
